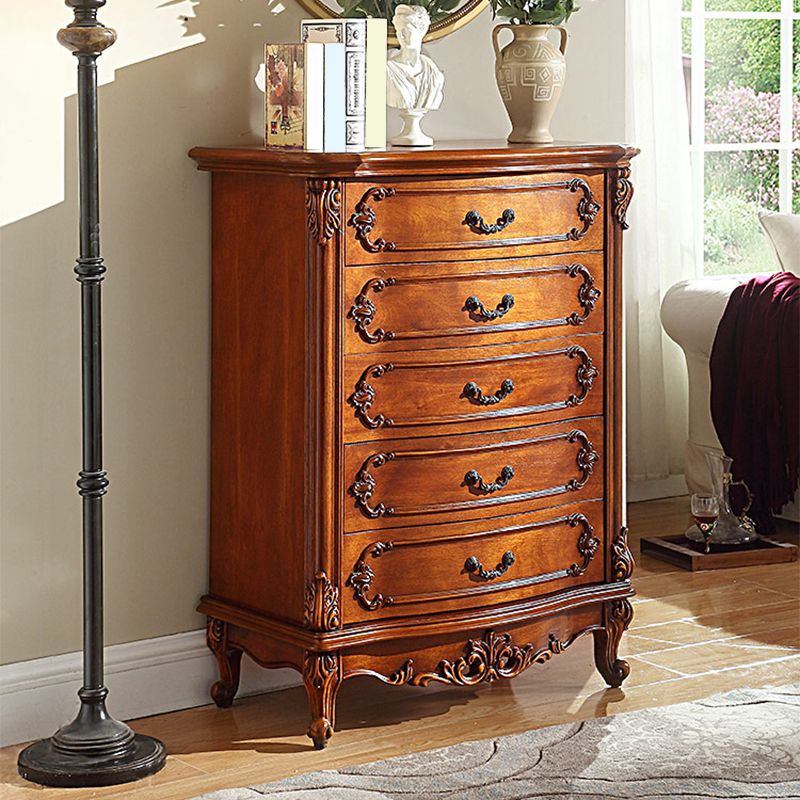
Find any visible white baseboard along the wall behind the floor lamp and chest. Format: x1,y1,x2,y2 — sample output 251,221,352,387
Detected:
0,631,300,746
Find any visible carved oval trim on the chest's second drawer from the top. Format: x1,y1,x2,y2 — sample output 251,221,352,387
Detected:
347,263,600,344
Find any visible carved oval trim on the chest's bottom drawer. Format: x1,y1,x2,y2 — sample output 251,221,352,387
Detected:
347,514,600,611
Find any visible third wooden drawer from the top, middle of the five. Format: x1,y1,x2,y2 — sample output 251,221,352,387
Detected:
343,334,603,442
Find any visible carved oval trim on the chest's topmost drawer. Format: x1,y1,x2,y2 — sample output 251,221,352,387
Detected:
347,178,600,253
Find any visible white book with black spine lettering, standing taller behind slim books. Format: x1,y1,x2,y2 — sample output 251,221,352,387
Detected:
300,19,367,150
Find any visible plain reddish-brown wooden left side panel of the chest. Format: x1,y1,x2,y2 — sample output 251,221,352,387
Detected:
210,173,307,622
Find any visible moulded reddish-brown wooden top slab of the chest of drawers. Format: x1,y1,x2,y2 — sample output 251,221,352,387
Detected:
189,139,639,178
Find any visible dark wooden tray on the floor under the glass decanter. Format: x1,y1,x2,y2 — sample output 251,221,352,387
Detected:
640,534,797,572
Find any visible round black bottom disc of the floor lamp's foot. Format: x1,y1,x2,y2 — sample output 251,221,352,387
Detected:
17,733,167,787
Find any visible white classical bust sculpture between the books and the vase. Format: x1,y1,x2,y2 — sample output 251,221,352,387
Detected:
386,5,444,147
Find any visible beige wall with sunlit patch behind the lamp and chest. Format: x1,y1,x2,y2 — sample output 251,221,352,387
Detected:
0,0,624,663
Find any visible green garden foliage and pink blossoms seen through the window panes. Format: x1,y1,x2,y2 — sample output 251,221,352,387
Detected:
682,0,800,274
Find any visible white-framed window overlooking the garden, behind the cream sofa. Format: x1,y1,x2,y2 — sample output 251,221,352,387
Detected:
682,0,800,275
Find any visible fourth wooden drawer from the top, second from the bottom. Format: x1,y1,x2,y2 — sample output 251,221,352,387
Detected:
342,417,604,533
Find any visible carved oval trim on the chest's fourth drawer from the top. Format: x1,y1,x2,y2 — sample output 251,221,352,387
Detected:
349,429,600,519
